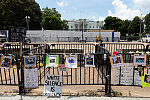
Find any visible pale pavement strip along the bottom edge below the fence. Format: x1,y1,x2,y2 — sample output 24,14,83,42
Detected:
0,95,150,100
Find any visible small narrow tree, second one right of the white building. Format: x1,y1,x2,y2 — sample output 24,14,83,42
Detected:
120,20,131,36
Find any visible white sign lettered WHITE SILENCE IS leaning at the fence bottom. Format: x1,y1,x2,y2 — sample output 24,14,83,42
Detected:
44,74,63,97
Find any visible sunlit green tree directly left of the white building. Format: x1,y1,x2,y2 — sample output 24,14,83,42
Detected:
41,7,68,30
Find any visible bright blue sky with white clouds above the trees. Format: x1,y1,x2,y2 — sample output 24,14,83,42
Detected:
35,0,150,21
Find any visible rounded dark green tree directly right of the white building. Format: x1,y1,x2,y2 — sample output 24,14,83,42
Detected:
104,16,122,31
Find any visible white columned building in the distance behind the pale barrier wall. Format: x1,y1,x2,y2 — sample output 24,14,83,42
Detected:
68,19,104,32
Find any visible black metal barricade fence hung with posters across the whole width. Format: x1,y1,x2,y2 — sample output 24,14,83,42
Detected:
0,43,150,94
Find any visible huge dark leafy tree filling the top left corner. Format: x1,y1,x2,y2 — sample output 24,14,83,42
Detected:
0,0,42,29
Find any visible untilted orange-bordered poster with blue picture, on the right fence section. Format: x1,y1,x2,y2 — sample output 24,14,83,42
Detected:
133,54,147,66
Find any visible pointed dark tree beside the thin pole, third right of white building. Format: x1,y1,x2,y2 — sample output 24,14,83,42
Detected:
129,16,144,36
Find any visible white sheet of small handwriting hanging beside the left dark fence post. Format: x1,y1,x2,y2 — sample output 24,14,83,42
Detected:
24,68,38,89
